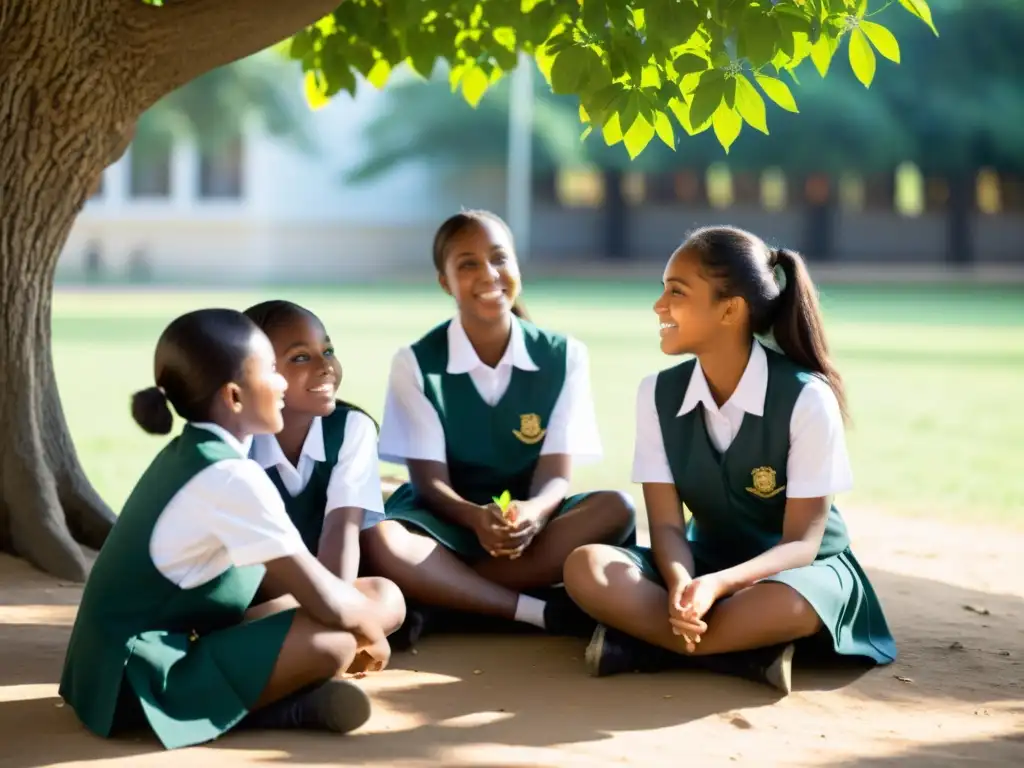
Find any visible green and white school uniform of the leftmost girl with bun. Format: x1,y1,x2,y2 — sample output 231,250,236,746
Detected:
59,423,304,749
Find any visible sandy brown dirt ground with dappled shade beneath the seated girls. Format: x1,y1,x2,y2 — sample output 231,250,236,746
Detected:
0,511,1024,768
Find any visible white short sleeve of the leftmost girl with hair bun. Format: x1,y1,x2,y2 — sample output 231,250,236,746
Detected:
208,459,305,567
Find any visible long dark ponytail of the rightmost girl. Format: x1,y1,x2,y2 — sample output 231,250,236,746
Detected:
768,248,848,420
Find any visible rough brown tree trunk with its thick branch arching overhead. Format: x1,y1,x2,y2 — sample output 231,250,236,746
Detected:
0,0,338,581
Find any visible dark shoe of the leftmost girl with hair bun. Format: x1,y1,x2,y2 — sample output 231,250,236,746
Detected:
244,680,371,733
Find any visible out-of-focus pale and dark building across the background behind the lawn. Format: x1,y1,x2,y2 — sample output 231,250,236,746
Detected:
58,82,1024,283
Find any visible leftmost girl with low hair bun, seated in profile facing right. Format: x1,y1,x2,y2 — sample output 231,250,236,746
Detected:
59,309,401,749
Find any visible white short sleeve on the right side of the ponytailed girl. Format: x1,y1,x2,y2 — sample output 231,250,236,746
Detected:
785,377,853,499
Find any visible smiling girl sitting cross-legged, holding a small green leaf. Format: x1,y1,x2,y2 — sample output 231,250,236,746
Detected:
374,211,634,635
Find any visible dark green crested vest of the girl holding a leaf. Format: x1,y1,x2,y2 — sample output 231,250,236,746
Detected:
413,318,566,504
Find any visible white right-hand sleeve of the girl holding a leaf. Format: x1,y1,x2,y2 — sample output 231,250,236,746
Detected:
541,339,603,465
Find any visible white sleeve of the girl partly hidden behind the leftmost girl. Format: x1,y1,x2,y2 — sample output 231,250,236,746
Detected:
324,411,384,527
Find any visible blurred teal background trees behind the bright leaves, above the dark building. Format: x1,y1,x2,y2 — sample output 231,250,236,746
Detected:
350,0,1024,181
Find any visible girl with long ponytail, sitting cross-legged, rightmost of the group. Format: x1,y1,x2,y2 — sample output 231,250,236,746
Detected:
565,226,896,693
